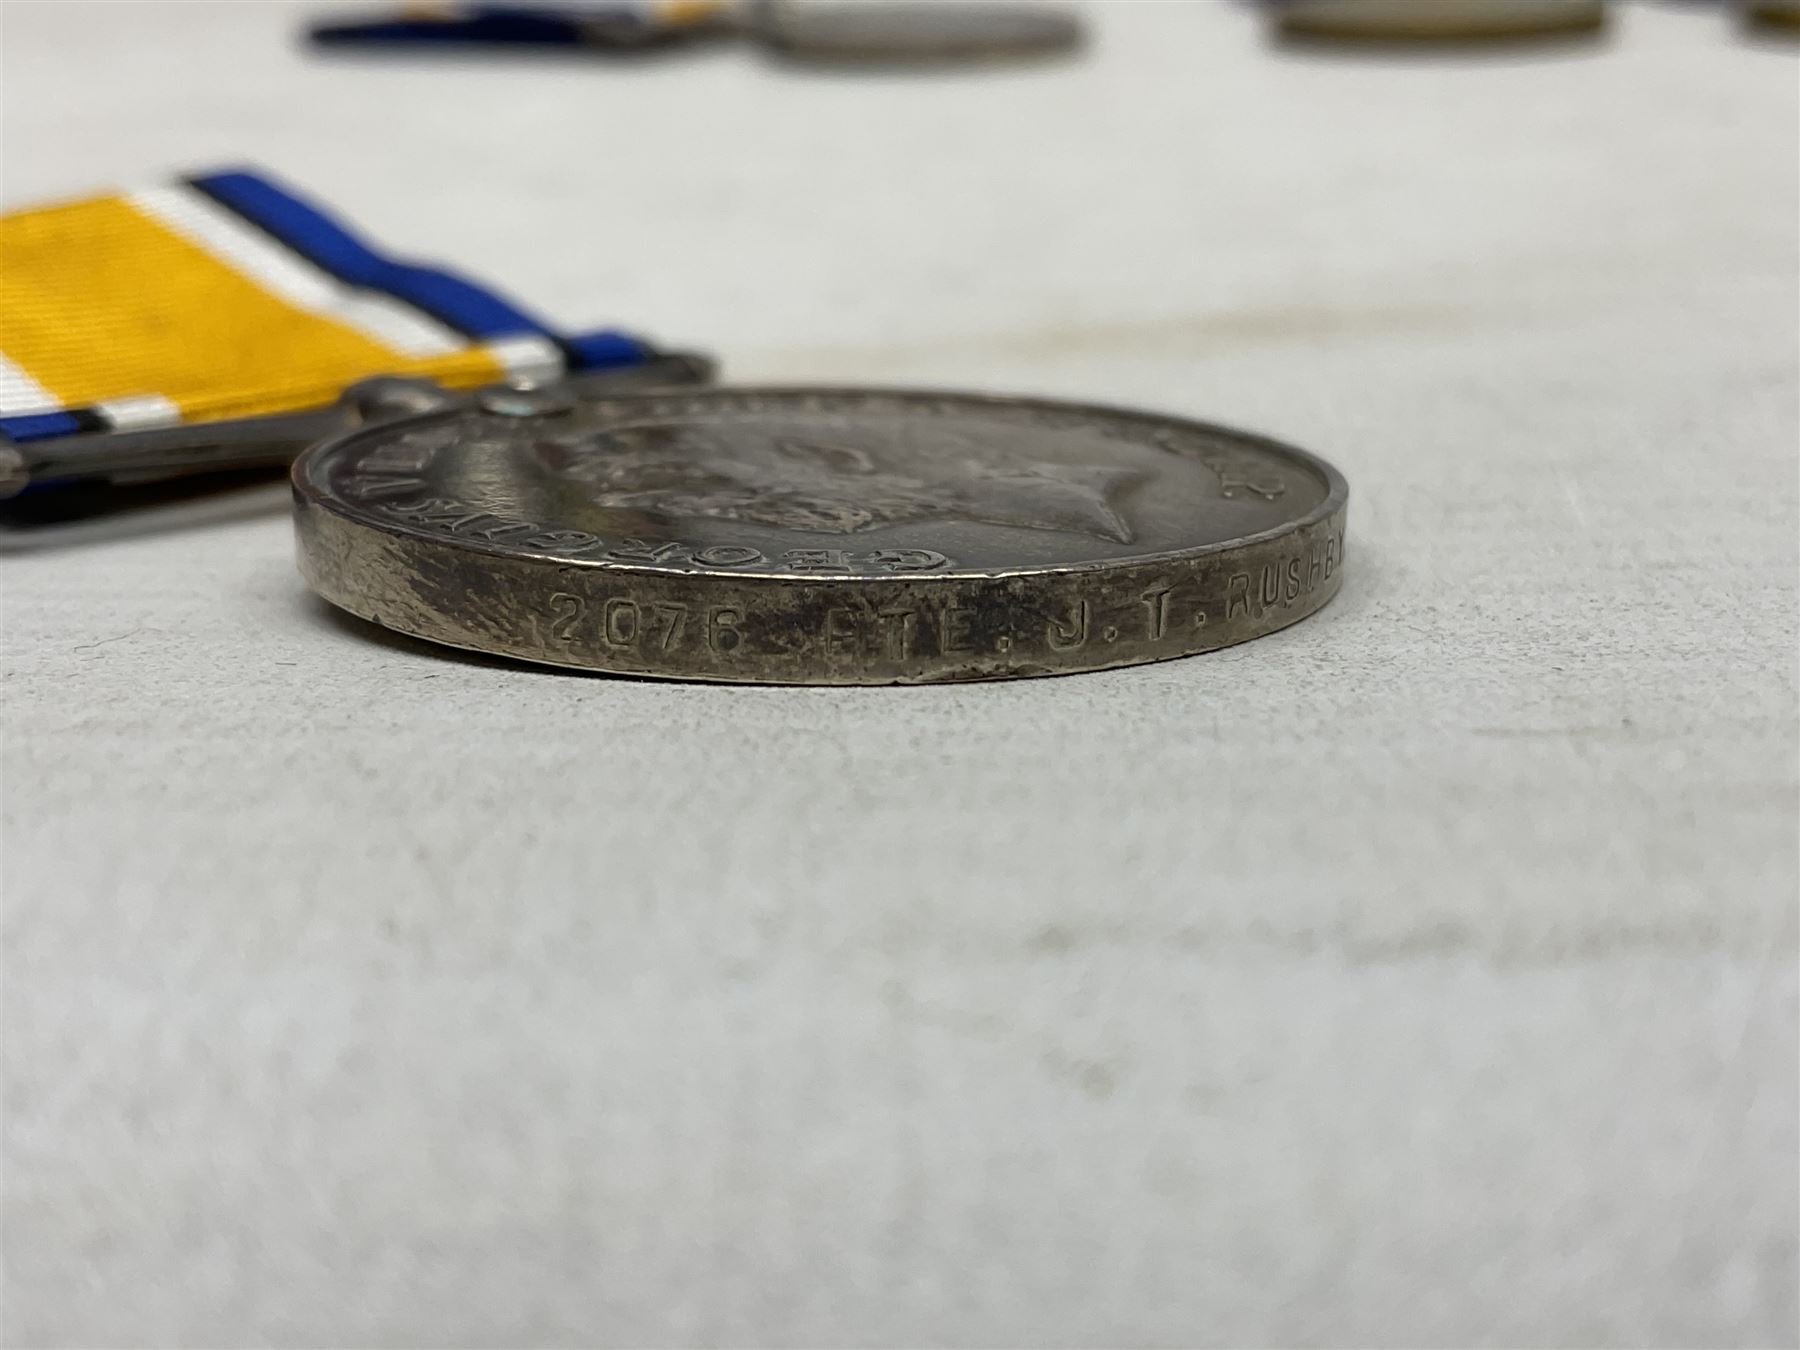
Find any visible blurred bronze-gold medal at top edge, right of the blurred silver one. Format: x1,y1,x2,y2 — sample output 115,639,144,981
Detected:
1276,0,1606,41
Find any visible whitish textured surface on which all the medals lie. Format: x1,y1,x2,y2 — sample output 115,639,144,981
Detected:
0,0,1800,1345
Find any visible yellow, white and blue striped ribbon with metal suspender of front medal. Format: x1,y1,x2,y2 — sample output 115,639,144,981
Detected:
0,169,713,499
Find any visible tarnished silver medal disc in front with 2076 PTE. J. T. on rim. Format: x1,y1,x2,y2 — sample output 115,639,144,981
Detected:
293,387,1346,684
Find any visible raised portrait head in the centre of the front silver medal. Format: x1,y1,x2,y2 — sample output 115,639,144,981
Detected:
526,416,1145,544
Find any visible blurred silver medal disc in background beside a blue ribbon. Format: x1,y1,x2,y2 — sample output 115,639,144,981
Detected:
760,0,1082,63
